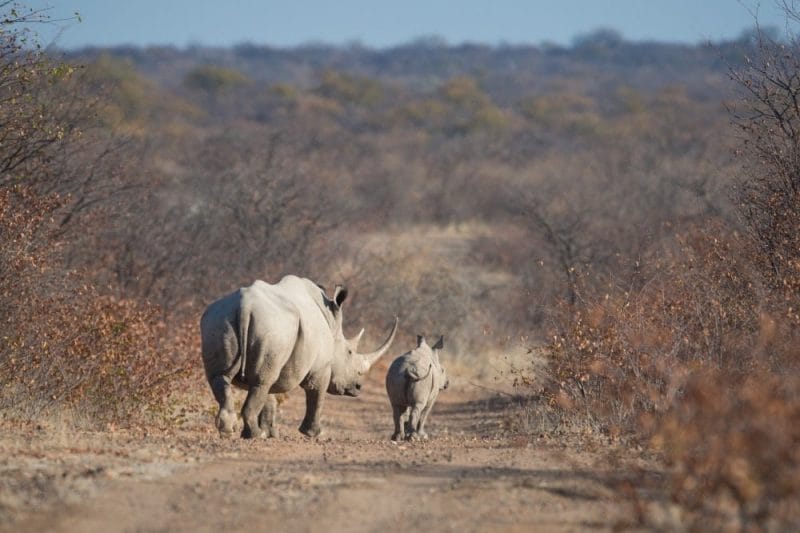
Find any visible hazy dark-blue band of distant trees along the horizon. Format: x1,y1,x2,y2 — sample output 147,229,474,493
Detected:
65,30,754,98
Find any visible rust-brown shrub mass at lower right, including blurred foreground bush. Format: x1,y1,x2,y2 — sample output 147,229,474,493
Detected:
519,221,800,530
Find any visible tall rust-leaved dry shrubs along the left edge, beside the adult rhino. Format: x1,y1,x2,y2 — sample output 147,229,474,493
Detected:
0,2,194,423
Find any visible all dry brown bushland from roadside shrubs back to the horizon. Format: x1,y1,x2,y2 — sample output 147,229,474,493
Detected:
0,2,800,530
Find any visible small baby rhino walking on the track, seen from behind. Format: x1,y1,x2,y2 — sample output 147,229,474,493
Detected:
386,335,449,441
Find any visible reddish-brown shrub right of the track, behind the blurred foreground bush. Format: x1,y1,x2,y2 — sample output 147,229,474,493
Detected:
523,223,766,435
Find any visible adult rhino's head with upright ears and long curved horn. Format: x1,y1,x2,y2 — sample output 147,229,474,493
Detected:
328,285,398,396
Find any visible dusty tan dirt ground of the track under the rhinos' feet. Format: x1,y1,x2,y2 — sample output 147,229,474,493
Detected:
0,370,628,532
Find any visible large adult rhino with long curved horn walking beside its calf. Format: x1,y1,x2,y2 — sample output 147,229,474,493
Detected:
200,276,398,438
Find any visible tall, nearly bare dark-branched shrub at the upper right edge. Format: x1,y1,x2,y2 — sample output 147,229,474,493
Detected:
730,31,800,311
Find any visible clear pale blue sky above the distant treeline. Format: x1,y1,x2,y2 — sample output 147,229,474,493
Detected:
32,0,783,48
